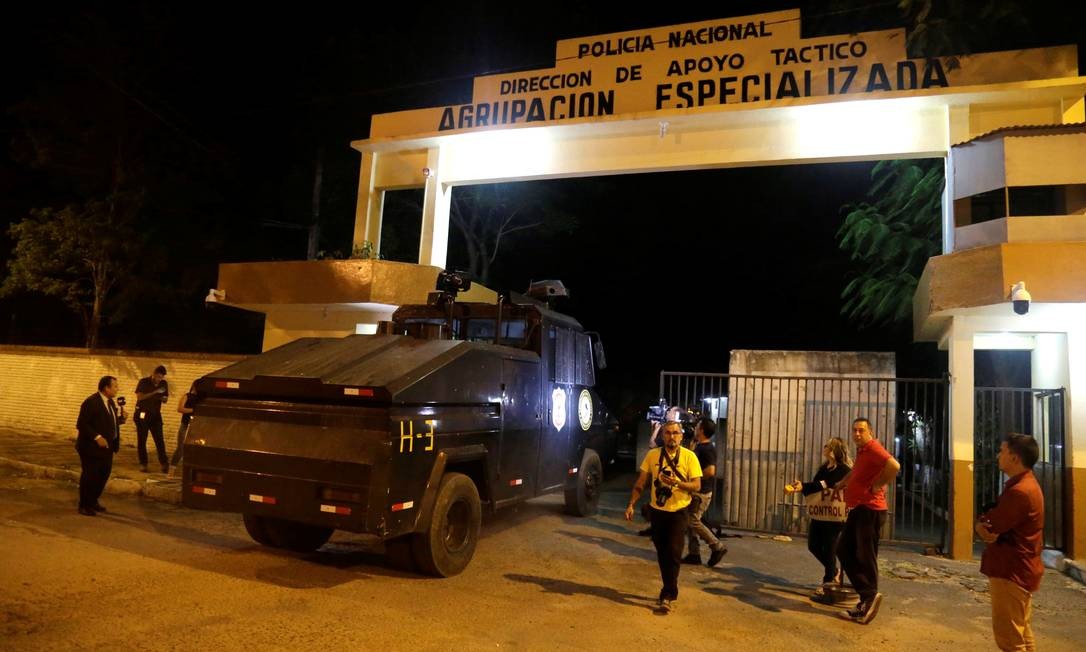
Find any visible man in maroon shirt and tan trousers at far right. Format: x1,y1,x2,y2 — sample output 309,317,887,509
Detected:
975,434,1045,650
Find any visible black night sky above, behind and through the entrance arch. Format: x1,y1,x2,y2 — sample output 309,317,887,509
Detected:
0,0,1086,415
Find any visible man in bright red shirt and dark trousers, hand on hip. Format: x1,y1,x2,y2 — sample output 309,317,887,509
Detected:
835,417,901,625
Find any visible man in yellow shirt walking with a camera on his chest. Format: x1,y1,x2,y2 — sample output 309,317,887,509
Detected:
626,422,702,614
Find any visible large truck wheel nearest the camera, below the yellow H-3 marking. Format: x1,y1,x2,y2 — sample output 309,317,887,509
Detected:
412,473,482,577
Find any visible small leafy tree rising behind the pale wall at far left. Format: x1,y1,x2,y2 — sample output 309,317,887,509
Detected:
0,195,140,348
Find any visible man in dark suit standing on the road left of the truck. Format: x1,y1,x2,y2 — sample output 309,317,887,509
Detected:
75,376,125,516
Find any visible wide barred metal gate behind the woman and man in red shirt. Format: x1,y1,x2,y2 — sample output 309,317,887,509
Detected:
660,372,950,548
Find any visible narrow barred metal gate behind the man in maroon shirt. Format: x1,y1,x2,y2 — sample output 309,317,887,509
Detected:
973,387,1064,550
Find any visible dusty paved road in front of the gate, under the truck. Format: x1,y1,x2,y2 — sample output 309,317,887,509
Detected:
0,469,1086,651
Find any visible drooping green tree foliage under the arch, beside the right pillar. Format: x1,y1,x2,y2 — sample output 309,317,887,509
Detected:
837,160,944,326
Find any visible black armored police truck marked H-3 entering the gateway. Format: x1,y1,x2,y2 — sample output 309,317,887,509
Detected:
182,273,617,576
